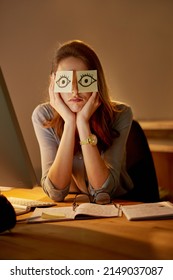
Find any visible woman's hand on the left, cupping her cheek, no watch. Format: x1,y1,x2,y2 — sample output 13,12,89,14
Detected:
49,74,76,122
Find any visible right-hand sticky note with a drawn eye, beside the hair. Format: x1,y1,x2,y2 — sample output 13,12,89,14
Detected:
76,70,98,93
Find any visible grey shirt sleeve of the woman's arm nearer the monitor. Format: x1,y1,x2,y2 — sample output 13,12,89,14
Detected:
32,103,74,201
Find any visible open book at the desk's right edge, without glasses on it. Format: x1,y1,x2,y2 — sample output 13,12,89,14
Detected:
121,201,173,221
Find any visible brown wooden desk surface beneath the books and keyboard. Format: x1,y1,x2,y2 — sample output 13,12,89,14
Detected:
0,187,173,260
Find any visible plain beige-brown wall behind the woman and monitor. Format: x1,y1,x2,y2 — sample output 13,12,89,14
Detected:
0,0,173,178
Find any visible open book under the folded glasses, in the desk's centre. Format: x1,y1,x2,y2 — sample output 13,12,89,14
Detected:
28,203,119,223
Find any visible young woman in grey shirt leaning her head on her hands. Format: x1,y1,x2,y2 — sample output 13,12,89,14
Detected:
32,40,133,204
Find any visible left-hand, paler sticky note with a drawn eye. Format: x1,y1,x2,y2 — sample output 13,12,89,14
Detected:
54,71,73,92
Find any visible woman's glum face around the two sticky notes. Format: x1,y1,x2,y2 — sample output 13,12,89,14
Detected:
57,56,92,113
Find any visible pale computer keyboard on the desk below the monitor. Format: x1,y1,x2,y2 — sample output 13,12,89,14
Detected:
7,197,56,208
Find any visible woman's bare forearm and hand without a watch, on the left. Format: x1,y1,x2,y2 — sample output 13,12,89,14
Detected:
48,76,76,189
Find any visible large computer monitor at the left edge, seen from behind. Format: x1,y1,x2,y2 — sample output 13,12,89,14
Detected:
0,68,38,190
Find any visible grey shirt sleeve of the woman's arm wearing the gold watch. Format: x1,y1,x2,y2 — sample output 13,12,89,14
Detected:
89,104,133,197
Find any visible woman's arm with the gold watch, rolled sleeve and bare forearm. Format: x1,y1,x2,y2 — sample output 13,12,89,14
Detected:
77,99,133,194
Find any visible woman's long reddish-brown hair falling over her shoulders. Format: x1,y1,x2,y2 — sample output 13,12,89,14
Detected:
46,40,118,151
